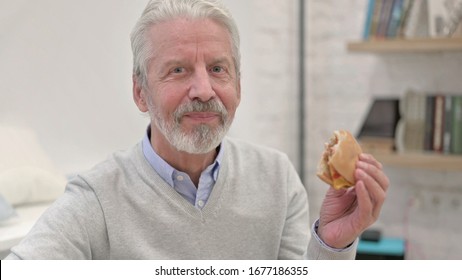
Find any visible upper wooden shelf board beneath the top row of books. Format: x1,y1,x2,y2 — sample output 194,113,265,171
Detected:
347,37,462,53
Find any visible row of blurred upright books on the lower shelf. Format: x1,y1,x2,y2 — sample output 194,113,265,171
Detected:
395,90,462,154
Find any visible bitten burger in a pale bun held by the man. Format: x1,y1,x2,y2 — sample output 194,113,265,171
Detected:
316,130,362,190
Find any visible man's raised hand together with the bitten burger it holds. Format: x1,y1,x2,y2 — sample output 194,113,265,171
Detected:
316,130,389,249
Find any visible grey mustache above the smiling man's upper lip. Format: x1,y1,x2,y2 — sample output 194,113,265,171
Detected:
173,99,228,122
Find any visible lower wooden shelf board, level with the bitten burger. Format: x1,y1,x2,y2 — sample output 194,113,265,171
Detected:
372,152,462,171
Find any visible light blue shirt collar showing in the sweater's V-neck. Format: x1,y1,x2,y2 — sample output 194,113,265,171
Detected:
142,127,223,209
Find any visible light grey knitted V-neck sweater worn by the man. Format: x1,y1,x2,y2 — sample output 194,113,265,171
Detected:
8,138,354,259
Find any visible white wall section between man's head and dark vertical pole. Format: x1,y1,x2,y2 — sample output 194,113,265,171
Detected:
225,0,298,164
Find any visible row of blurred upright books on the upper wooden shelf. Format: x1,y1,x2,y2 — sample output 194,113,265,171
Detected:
363,0,462,40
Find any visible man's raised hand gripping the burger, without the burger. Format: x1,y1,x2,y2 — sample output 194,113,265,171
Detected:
318,154,389,248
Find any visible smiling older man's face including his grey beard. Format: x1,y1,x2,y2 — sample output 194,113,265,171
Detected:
143,19,240,154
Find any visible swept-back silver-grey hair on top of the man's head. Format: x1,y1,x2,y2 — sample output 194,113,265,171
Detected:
131,0,241,87
